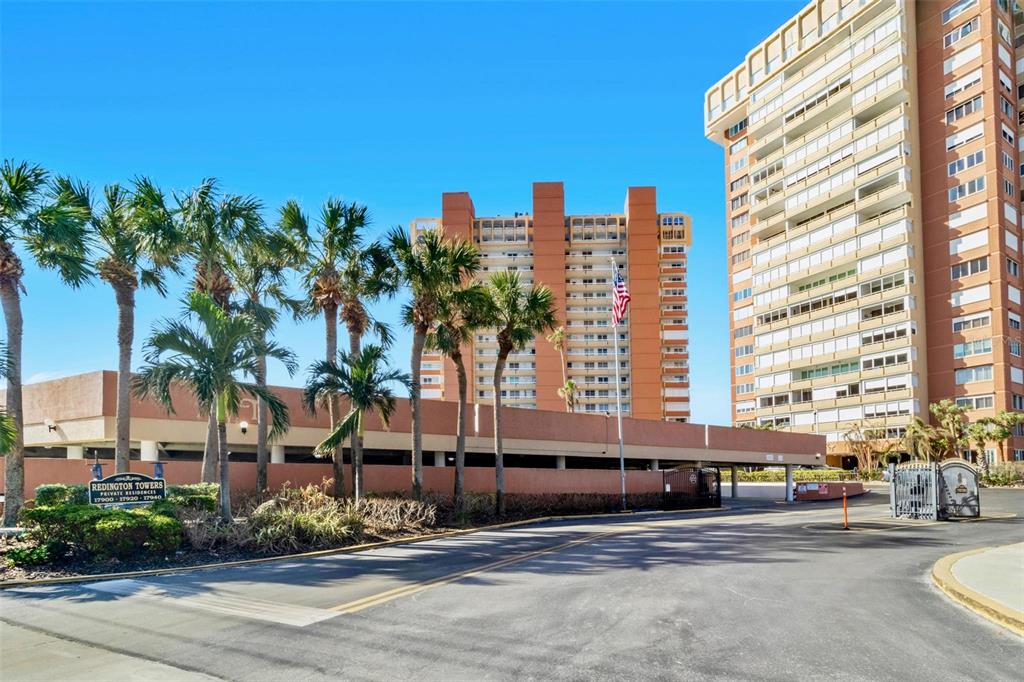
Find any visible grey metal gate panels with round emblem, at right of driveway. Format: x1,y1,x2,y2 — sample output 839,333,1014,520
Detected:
889,460,981,520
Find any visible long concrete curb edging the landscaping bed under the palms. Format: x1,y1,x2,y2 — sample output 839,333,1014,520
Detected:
0,505,731,590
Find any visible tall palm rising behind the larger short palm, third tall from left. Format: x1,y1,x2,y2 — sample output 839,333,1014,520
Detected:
174,178,263,482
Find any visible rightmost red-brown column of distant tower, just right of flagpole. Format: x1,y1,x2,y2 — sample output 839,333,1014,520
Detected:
626,187,663,419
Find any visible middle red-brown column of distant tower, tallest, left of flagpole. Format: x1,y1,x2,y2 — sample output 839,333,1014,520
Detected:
534,182,565,411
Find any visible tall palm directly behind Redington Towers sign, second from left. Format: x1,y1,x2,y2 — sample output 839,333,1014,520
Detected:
70,177,183,473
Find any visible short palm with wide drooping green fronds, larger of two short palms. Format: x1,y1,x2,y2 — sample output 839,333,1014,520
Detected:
133,291,295,522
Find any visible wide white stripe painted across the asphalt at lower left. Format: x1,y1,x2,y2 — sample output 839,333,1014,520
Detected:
82,580,338,628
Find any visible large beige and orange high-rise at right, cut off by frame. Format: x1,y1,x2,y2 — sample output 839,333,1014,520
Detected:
705,0,1024,463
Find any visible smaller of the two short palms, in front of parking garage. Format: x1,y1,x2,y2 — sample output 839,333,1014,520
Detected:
302,345,410,501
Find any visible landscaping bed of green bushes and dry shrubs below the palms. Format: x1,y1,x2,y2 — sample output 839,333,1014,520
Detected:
0,481,662,582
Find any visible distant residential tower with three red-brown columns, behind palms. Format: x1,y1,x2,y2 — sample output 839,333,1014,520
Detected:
412,182,691,422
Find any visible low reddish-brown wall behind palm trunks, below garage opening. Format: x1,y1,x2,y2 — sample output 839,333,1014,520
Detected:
0,457,663,499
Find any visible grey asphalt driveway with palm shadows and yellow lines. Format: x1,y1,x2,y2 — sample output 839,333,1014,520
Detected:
0,491,1024,681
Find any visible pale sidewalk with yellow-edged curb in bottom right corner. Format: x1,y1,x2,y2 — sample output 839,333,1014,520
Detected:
932,543,1024,636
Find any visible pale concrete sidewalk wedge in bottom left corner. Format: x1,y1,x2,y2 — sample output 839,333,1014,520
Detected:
0,623,217,682
